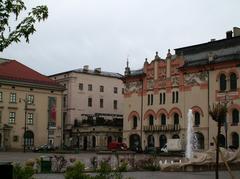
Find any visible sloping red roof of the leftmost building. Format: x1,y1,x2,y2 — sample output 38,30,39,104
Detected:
0,60,61,88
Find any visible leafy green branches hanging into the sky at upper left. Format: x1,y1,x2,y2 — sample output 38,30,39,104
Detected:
0,0,48,52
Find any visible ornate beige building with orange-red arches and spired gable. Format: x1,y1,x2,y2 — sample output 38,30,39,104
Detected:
123,28,240,150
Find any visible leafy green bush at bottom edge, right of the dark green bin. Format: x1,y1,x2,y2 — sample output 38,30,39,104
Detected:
65,161,92,179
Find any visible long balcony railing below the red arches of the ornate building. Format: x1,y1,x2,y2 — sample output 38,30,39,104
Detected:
143,124,180,132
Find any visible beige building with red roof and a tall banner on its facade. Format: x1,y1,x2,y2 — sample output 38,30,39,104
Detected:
0,59,64,150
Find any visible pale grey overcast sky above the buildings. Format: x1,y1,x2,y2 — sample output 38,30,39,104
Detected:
0,0,240,75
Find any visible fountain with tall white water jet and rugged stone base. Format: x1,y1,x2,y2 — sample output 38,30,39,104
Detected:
159,109,240,171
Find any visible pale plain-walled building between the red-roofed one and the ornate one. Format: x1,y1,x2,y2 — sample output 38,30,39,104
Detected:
50,66,123,150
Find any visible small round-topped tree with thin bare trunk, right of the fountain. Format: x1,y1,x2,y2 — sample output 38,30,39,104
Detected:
209,103,227,179
